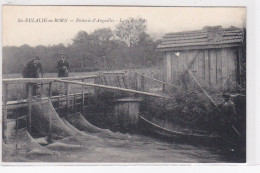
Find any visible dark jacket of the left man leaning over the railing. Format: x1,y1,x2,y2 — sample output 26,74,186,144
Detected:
22,60,43,78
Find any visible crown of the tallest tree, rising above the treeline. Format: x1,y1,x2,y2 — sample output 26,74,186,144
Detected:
115,18,146,47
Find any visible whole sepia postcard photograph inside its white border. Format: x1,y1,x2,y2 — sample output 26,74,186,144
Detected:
1,5,247,164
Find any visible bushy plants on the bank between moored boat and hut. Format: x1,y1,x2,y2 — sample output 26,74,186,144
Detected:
141,76,222,131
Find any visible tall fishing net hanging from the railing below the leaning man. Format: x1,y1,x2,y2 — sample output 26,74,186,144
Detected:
32,100,77,139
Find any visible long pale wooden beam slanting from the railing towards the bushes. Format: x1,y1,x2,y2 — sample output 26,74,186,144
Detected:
56,79,171,99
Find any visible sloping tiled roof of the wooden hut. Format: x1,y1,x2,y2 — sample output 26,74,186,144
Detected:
157,26,245,51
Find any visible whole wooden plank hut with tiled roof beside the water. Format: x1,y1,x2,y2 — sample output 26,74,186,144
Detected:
157,26,246,91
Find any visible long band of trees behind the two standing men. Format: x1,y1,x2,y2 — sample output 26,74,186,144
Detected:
3,18,162,73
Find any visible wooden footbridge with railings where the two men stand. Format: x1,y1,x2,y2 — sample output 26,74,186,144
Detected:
2,72,176,143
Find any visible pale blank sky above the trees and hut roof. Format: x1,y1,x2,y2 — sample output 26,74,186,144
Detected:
3,6,246,46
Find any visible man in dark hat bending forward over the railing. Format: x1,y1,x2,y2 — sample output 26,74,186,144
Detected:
22,56,44,95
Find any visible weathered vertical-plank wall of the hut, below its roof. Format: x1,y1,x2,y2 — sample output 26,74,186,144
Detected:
165,47,245,91
